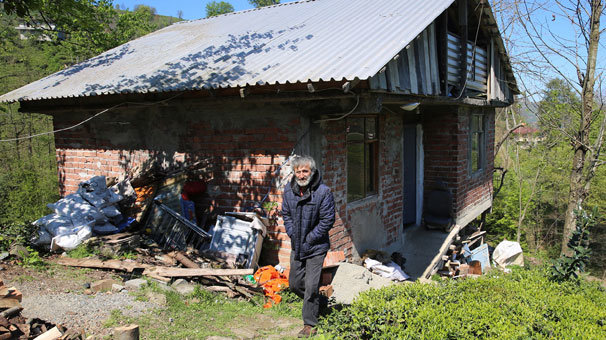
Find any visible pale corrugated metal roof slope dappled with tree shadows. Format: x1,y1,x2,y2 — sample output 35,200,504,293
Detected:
0,0,454,102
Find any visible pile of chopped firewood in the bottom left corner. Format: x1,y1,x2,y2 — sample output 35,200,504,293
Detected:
0,279,84,340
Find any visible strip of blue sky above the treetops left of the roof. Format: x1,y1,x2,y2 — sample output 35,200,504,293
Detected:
114,0,292,20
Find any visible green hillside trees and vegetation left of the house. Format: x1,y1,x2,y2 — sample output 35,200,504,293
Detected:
0,1,180,235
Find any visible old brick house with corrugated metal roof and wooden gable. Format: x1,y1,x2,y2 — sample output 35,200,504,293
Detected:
0,0,518,276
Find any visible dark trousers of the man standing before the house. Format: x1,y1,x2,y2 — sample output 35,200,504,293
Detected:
288,252,326,326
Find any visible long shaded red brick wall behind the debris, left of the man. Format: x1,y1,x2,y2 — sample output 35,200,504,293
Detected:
54,103,302,264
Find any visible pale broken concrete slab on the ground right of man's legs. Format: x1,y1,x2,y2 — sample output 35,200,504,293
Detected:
331,263,393,304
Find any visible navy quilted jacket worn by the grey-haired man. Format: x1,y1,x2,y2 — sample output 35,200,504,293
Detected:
282,170,335,260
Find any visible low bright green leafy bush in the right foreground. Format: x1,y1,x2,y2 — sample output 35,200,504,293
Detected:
318,268,606,339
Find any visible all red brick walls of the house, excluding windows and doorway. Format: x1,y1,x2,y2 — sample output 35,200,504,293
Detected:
47,104,494,264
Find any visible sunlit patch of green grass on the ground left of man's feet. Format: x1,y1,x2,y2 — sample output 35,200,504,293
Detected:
109,282,302,340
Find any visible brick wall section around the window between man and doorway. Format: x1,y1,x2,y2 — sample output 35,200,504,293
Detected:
322,114,403,257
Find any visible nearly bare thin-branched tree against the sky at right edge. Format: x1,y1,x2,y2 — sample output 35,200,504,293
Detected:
508,0,606,254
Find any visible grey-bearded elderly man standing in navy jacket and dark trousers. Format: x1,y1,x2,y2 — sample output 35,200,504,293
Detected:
282,156,335,337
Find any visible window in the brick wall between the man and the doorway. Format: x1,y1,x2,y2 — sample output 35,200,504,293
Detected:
347,117,379,202
